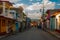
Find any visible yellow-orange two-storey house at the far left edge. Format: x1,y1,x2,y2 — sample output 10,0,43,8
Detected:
0,1,16,35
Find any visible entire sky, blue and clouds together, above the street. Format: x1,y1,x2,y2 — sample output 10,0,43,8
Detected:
3,0,60,19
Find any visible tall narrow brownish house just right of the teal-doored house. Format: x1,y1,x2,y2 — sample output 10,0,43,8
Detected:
18,6,26,31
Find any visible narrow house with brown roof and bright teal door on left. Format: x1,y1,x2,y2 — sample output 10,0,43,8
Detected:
10,7,21,32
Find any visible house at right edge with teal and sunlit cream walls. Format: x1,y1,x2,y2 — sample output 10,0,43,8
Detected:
47,9,60,32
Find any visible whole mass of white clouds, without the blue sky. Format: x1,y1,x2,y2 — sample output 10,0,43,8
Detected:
9,0,55,19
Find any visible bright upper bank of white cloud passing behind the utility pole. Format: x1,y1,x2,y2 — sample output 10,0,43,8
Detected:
27,0,55,10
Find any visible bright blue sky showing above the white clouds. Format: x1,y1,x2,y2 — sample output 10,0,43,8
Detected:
9,0,60,9
